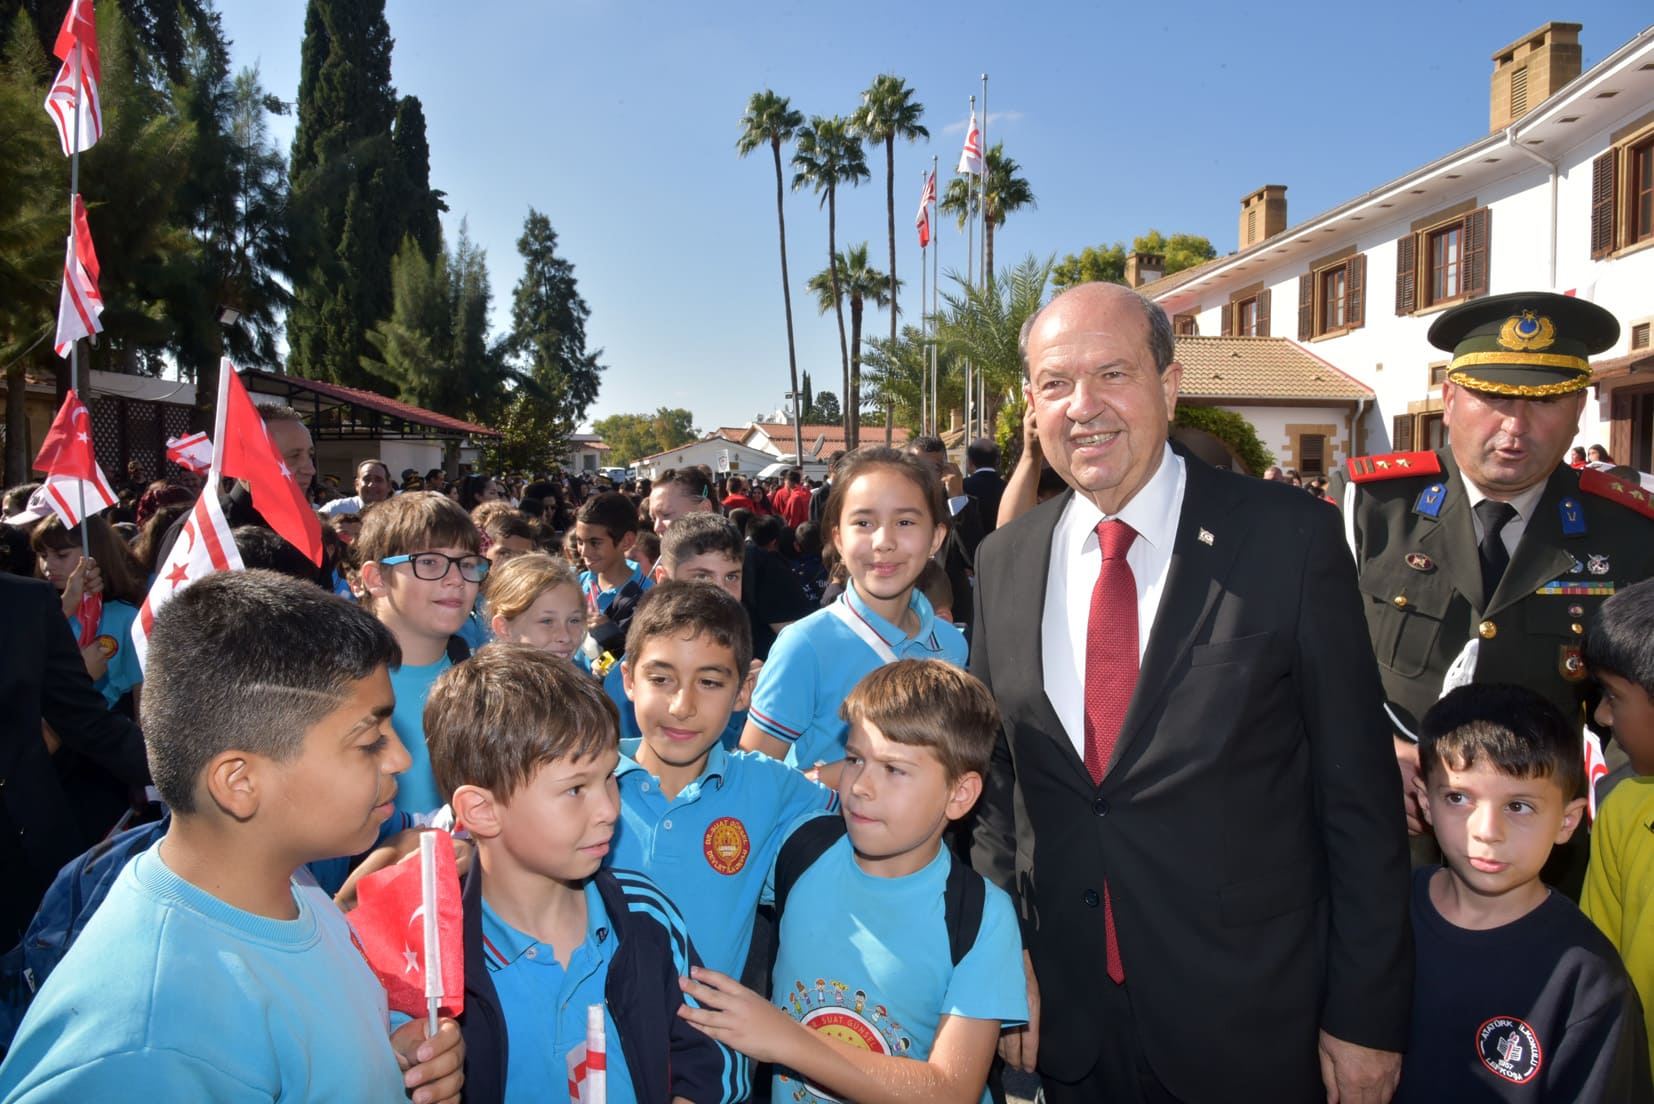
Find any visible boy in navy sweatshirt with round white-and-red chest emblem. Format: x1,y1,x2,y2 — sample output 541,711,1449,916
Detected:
1394,684,1654,1104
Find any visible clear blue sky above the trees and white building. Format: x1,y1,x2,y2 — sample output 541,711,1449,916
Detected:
220,0,1654,430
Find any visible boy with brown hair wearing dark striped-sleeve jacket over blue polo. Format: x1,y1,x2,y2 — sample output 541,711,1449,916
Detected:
425,644,741,1104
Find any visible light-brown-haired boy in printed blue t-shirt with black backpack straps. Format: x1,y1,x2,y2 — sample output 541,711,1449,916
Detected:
680,659,1029,1104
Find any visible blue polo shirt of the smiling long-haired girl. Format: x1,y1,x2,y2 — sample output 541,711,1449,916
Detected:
751,583,966,770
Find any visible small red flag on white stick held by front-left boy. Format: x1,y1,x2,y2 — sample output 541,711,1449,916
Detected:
349,831,465,1018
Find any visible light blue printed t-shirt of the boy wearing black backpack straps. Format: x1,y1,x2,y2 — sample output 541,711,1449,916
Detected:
769,836,1029,1104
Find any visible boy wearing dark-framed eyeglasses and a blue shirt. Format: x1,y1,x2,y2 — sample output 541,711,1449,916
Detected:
356,495,488,813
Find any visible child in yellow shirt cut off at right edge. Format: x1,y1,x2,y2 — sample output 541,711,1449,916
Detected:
1580,581,1654,1072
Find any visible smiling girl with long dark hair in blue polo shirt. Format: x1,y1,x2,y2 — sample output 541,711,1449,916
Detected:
741,449,966,785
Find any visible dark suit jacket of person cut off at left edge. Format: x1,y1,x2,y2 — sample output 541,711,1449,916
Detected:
0,574,149,945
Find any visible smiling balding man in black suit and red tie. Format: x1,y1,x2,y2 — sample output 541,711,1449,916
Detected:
973,285,1413,1104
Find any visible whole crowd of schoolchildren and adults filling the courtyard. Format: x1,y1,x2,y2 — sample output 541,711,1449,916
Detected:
0,285,1654,1104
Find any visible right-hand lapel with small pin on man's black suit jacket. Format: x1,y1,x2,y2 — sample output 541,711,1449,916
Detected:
1111,450,1245,778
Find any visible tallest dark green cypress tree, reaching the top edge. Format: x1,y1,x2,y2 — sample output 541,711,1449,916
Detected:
288,0,440,387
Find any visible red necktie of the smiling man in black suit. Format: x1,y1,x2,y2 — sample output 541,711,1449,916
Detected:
1085,521,1138,985
